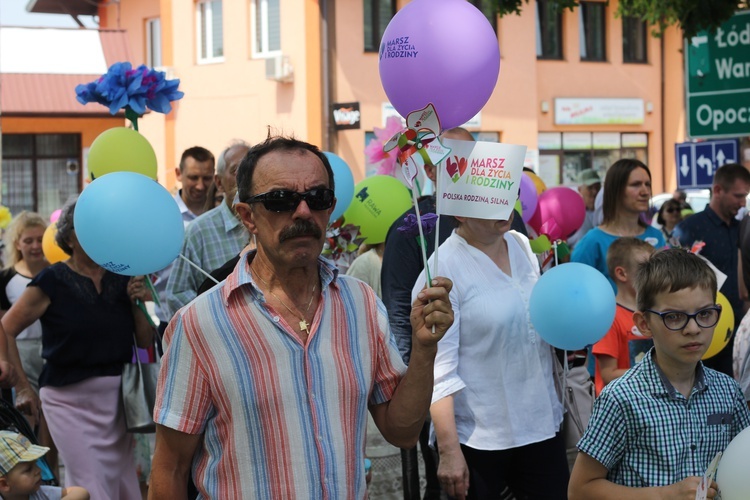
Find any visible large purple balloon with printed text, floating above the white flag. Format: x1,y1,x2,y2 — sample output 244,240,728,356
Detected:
380,0,500,130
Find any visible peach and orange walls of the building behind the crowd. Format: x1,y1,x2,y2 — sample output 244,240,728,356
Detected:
97,0,684,192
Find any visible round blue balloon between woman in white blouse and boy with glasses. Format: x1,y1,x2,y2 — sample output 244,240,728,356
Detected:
529,262,615,351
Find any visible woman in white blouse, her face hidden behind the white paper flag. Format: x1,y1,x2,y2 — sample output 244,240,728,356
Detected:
413,212,568,500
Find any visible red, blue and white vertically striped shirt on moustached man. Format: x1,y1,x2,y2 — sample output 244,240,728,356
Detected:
154,252,406,500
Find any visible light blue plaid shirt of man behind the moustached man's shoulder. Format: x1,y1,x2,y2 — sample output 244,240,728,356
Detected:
166,203,250,318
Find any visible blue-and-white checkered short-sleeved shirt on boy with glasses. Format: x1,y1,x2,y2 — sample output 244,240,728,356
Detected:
578,349,750,487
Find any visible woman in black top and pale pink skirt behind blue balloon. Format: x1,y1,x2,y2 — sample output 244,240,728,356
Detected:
2,200,153,500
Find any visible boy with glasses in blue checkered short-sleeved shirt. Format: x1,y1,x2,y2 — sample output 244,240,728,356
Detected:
568,248,750,499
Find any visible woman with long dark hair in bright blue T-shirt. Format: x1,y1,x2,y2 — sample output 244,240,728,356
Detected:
570,159,664,291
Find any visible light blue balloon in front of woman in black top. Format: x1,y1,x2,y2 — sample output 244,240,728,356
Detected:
73,172,185,276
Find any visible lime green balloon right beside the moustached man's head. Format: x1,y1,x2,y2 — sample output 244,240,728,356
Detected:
344,175,412,244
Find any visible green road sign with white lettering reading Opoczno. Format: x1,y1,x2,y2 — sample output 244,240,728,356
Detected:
685,11,750,138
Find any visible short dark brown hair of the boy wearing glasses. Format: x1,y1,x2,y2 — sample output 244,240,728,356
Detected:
635,248,716,311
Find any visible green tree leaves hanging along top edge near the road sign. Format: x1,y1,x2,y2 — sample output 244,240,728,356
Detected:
491,0,747,38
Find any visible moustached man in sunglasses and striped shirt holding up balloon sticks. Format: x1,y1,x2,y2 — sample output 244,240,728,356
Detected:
149,138,453,499
